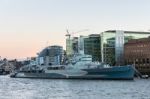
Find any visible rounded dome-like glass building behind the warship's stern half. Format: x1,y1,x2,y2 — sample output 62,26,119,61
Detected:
37,46,64,65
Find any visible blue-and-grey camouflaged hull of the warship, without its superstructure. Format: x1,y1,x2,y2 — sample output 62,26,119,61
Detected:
11,66,134,80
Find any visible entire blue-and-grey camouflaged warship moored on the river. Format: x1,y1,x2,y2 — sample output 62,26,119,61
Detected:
10,54,135,80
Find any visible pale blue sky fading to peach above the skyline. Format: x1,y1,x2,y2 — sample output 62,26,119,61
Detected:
0,0,150,59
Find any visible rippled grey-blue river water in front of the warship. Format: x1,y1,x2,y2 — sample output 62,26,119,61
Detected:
0,76,150,99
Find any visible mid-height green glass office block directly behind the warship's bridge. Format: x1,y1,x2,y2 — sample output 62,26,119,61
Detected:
66,34,101,62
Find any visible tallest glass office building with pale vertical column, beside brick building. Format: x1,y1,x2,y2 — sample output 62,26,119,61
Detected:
101,30,150,65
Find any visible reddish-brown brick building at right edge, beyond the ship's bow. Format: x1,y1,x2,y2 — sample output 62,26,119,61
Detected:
124,38,150,75
